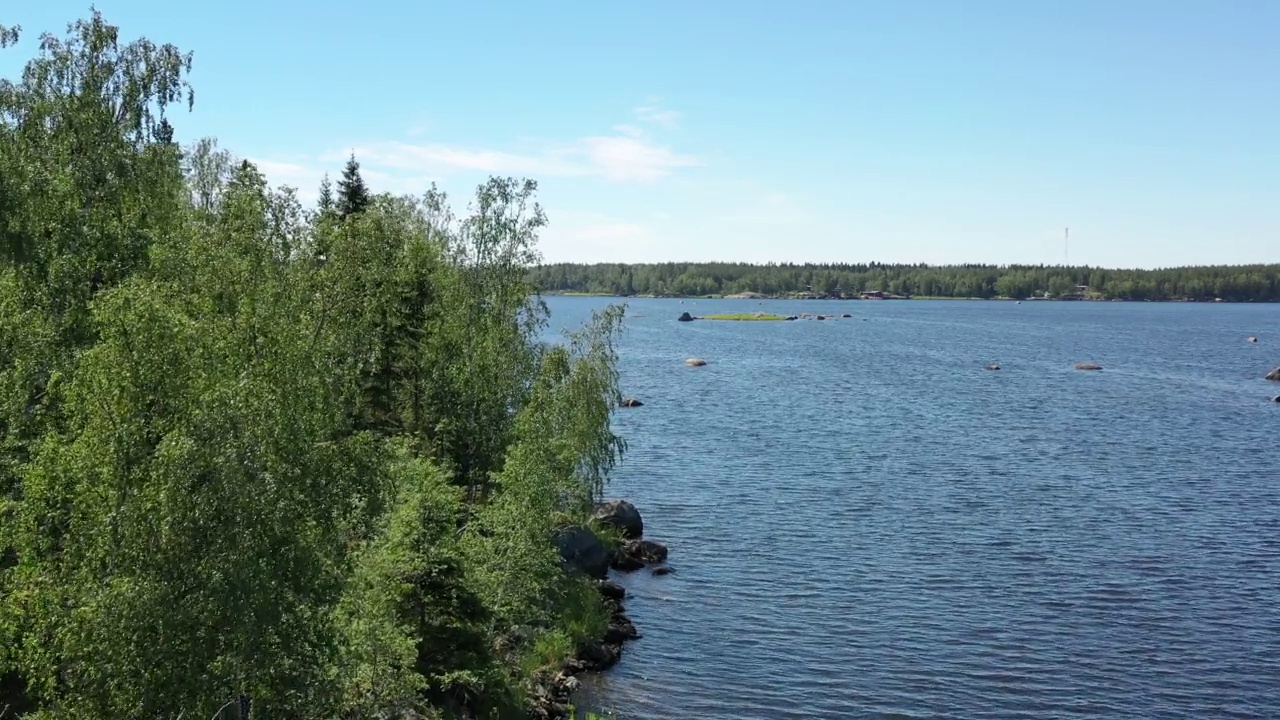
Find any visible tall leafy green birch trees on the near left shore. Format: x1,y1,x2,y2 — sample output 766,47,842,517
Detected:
0,13,623,719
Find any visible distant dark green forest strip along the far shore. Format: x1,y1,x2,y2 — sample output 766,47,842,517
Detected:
531,263,1280,302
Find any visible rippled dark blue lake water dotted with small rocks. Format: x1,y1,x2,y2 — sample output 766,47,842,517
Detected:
549,297,1280,720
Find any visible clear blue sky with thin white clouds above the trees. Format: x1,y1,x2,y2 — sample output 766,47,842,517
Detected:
0,0,1280,266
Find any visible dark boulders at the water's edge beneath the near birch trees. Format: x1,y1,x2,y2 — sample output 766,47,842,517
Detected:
529,500,673,720
